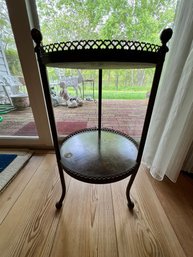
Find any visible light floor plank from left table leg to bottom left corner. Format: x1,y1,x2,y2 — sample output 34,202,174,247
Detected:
0,154,59,257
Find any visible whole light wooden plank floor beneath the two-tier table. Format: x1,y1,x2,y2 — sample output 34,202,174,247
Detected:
0,153,193,257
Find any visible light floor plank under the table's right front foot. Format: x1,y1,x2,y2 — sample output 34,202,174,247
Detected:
112,170,185,257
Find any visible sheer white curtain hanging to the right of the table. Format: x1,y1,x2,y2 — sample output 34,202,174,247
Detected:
142,0,193,182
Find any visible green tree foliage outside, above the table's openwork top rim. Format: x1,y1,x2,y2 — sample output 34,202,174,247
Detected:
37,0,177,43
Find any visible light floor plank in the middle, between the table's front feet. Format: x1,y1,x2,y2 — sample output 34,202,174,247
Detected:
51,180,118,257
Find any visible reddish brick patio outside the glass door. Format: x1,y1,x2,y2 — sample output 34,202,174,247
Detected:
0,100,147,140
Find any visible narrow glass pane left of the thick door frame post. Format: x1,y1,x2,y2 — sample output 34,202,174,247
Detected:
0,0,37,136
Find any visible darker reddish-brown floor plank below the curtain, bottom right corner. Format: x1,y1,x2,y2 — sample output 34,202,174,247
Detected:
147,167,193,257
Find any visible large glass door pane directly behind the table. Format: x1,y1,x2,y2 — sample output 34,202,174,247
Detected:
36,0,177,140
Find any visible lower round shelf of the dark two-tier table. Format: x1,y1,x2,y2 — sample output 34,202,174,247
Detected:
60,128,138,184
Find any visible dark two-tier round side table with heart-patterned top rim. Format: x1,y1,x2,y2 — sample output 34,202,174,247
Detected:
31,29,172,209
